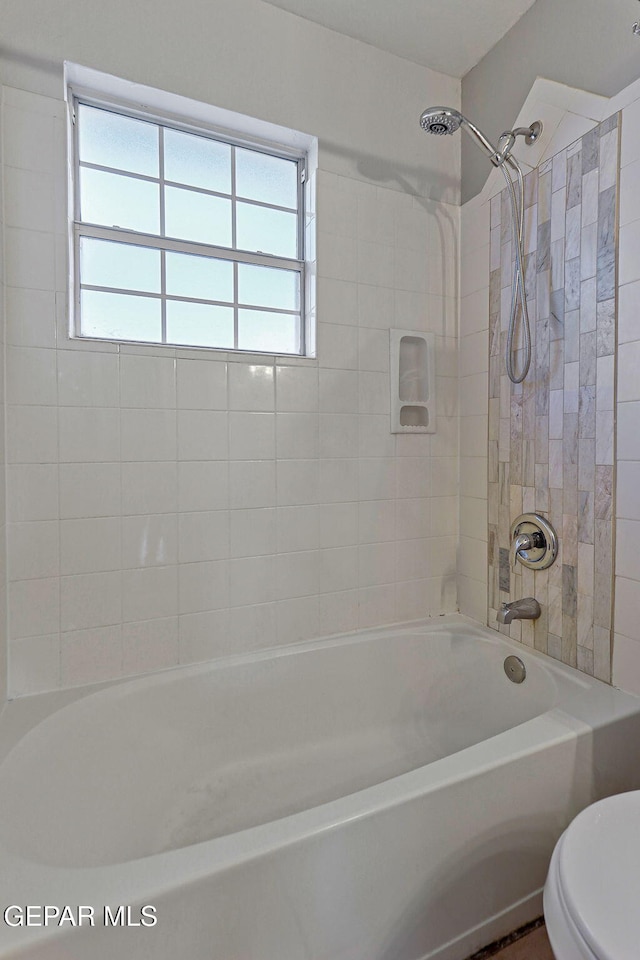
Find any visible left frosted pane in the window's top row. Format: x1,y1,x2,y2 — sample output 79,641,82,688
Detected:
78,103,159,177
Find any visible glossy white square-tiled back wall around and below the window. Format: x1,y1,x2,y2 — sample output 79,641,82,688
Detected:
0,87,459,695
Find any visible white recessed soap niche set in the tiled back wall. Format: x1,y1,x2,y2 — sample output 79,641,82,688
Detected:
390,330,436,433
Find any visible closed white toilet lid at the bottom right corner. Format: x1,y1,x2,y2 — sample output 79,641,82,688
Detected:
558,790,640,960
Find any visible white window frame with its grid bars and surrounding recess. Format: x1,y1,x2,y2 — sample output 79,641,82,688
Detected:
65,63,317,358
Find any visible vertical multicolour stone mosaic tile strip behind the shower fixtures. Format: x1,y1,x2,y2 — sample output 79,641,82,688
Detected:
488,115,619,680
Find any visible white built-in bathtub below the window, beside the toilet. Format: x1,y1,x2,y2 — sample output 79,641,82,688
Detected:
0,617,640,960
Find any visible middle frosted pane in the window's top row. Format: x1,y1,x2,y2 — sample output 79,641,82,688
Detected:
164,129,231,193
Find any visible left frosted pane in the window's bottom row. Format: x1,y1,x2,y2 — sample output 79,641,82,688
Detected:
81,290,162,343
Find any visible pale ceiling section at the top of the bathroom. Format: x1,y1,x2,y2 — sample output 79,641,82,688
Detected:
266,0,535,77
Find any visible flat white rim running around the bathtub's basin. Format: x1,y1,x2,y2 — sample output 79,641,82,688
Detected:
0,614,640,955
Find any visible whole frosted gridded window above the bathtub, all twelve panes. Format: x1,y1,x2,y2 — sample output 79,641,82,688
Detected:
72,97,309,355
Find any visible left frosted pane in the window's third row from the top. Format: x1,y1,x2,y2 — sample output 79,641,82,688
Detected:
80,237,161,293
